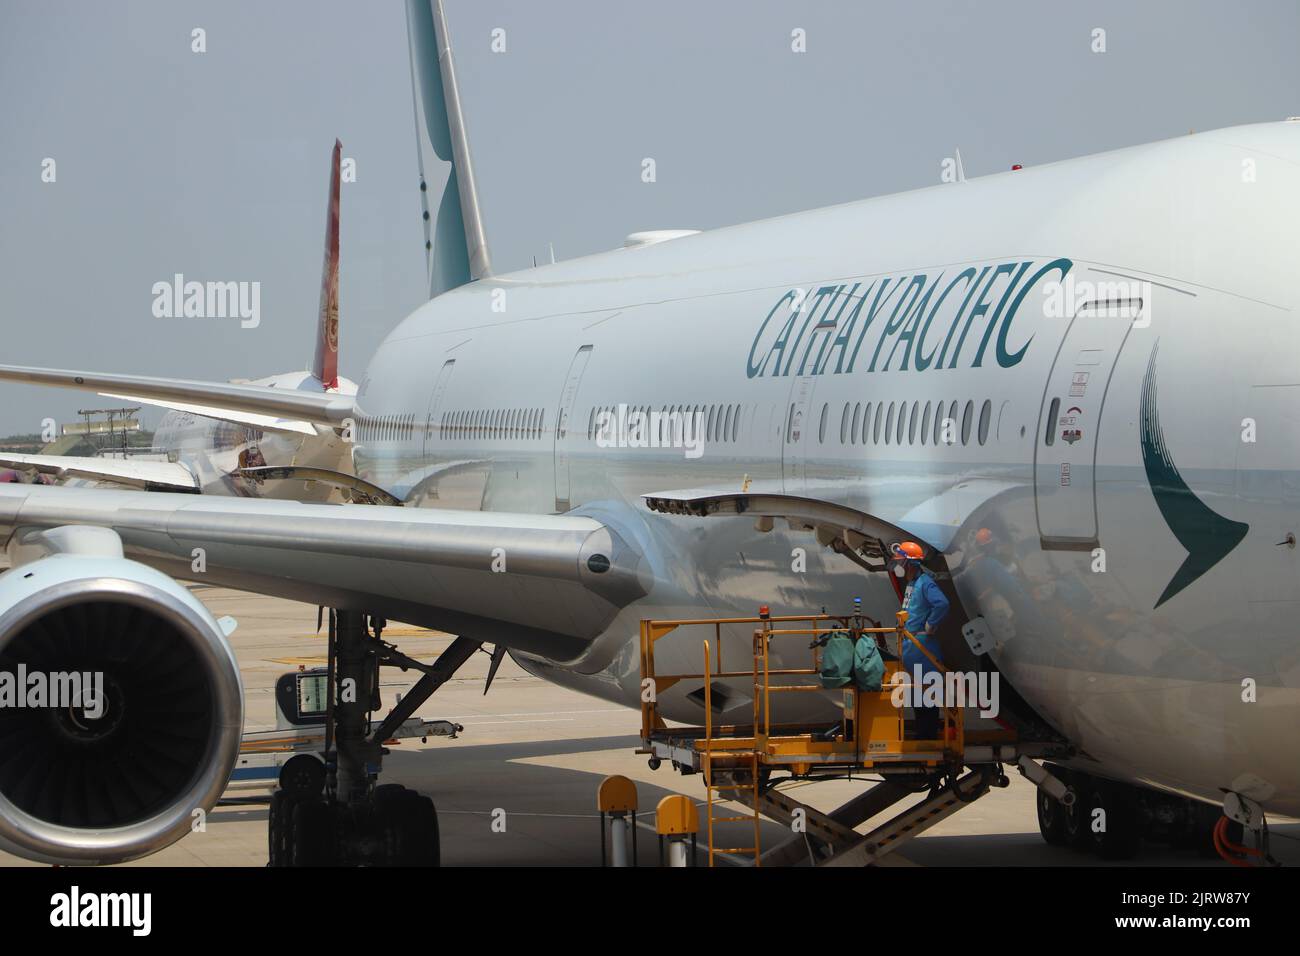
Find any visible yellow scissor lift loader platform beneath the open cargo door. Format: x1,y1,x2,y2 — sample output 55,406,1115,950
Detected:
638,609,1017,866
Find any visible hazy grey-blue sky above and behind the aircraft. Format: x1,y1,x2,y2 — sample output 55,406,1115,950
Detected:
0,0,1300,434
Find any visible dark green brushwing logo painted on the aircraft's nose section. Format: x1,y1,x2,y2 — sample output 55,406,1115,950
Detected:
1141,342,1251,610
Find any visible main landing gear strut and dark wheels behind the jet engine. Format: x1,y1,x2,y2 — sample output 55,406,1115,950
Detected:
268,610,480,866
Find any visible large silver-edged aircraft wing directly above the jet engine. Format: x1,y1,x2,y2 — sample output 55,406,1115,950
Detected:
0,484,651,662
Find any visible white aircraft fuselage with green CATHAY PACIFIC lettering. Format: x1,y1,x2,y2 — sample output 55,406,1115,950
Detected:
354,122,1300,814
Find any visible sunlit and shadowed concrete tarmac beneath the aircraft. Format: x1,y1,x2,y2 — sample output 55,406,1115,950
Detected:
0,587,1300,866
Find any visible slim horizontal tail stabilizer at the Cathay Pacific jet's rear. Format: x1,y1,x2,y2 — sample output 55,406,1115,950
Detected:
0,365,354,431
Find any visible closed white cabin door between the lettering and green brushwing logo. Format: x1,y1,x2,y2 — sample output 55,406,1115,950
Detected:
1034,299,1143,550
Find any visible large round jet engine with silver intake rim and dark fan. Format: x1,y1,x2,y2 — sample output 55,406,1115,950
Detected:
0,546,243,864
